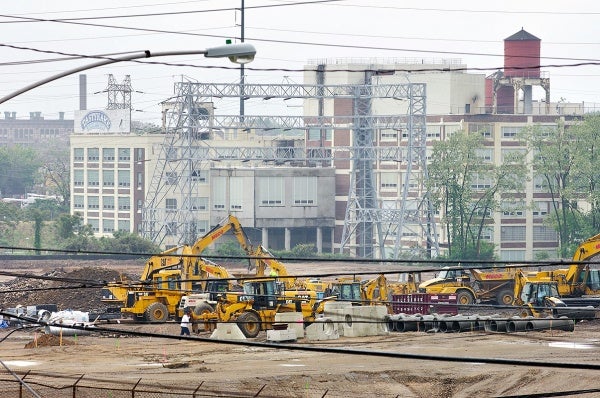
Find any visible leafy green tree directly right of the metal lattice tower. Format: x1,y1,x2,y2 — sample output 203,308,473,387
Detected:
428,131,526,259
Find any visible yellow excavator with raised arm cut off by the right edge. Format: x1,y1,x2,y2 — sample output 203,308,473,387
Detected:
527,234,600,297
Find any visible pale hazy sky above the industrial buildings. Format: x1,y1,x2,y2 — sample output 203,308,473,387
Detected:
0,0,600,122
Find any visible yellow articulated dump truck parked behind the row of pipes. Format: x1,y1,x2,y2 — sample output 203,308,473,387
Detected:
419,267,515,305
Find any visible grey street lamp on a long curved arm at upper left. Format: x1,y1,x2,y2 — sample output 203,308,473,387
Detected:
0,43,256,104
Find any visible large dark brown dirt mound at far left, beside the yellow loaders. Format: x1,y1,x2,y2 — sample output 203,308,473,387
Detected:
0,267,130,312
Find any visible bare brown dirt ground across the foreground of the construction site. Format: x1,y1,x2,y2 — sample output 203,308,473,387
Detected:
0,258,600,397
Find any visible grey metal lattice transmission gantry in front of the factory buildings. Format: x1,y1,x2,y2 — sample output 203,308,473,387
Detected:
142,82,439,256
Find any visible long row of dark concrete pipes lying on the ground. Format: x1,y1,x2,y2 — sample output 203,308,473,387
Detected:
386,314,575,333
